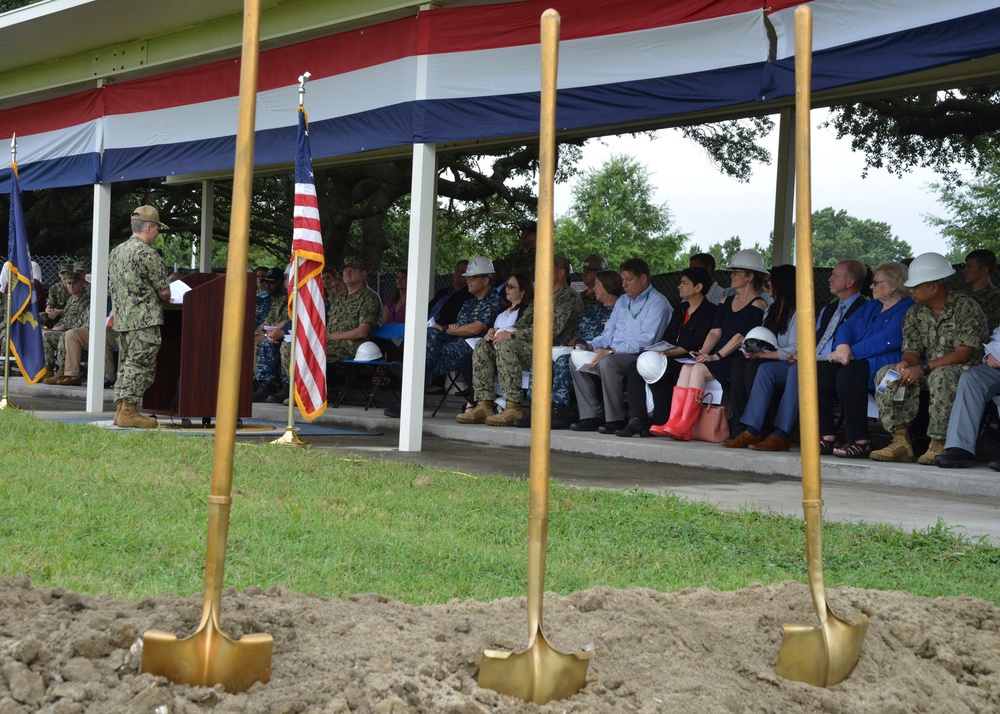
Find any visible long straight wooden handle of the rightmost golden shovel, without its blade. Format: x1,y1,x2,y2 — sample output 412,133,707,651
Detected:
795,5,820,501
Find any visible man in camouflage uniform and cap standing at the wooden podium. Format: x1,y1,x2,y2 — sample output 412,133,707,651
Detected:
108,206,170,429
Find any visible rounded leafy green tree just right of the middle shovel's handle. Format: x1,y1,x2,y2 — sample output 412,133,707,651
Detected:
555,156,687,274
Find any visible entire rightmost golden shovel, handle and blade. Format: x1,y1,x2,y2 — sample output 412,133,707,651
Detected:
775,6,868,687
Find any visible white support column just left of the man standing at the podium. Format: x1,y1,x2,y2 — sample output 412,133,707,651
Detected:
87,183,111,413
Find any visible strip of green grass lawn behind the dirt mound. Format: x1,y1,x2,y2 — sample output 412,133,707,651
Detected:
0,411,1000,604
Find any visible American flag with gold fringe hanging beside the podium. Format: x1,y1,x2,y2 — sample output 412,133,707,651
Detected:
288,107,326,419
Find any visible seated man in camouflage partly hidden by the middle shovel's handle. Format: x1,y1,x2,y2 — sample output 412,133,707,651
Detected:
455,253,583,426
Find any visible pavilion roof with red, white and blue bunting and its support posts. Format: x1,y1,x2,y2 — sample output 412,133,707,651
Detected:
0,0,1000,444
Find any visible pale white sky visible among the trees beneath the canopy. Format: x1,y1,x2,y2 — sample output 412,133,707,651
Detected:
554,111,948,255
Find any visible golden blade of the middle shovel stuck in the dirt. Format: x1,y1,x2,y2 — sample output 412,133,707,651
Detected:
479,632,594,704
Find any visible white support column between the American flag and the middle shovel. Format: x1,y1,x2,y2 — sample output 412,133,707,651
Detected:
399,144,437,451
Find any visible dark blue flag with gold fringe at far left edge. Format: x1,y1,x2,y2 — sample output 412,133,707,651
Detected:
0,163,45,384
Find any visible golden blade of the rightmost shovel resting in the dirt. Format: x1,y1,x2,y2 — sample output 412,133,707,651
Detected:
774,609,868,687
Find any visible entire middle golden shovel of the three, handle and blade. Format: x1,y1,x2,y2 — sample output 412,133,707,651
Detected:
479,9,594,704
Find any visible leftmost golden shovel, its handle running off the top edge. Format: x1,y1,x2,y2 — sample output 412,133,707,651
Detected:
141,0,274,692
